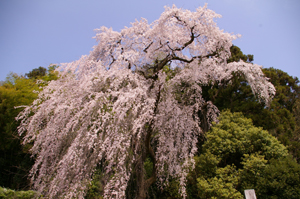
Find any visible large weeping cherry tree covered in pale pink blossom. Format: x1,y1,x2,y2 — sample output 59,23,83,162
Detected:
17,6,275,198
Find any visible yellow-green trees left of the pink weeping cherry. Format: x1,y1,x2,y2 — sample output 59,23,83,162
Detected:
0,66,57,190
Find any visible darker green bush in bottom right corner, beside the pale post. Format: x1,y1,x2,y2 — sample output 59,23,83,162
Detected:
240,156,300,199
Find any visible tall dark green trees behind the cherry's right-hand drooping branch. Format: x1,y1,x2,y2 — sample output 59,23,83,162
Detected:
203,46,300,161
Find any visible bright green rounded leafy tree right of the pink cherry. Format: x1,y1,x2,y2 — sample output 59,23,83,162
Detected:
188,111,299,198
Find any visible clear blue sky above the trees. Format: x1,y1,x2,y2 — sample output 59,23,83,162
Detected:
0,0,300,80
